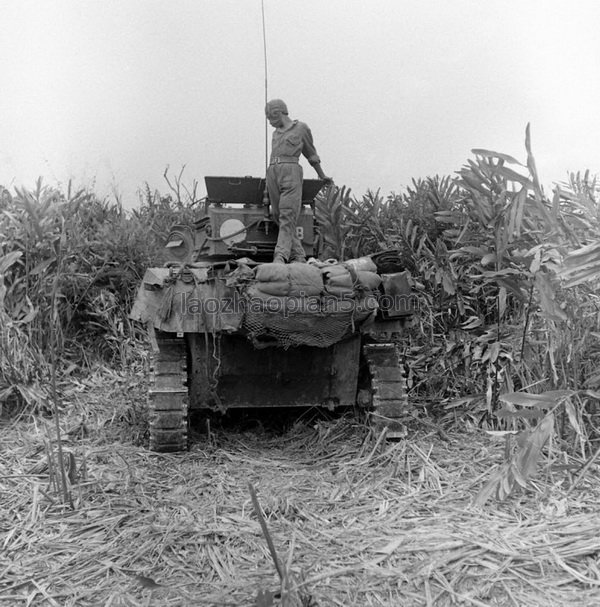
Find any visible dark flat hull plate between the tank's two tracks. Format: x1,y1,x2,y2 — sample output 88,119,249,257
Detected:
186,334,361,411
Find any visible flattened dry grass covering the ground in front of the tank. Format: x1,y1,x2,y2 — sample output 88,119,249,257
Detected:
0,373,600,607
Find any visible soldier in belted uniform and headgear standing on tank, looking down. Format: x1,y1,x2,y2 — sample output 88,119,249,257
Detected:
265,99,332,263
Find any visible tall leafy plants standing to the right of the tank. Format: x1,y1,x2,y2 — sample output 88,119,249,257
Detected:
317,127,600,495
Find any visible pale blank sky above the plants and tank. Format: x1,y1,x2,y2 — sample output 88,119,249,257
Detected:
0,0,600,205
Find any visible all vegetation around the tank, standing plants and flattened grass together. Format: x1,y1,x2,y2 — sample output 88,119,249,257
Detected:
0,129,600,607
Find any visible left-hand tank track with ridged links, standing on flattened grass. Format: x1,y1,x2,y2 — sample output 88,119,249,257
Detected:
148,333,189,452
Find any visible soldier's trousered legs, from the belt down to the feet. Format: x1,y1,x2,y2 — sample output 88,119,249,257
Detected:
267,163,306,261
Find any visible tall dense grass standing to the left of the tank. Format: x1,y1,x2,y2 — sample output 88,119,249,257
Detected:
0,179,192,409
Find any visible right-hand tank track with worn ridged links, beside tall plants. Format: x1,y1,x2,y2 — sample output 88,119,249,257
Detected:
363,342,409,438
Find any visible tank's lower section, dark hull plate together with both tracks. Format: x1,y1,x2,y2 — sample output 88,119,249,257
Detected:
148,332,409,452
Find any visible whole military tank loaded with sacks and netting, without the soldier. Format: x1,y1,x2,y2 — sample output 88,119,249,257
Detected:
130,177,416,452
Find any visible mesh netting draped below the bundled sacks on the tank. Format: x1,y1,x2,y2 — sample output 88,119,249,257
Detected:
243,288,377,348
